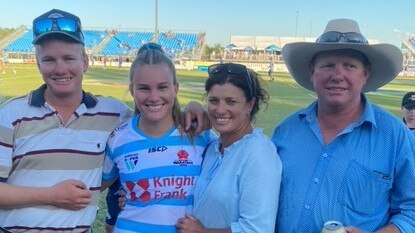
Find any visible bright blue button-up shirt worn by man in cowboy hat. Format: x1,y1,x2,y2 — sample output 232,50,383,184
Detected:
272,95,415,233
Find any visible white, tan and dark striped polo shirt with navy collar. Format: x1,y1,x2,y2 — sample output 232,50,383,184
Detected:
0,85,131,233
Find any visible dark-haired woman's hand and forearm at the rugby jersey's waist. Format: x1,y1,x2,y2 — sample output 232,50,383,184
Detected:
176,215,232,233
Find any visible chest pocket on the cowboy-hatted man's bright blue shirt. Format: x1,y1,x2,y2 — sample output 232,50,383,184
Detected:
338,161,392,215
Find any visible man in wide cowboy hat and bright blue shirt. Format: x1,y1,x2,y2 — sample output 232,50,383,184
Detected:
272,19,415,233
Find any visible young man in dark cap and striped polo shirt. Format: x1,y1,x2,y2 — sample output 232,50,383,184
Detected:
0,9,131,233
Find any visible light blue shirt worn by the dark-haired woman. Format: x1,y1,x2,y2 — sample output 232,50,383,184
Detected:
193,129,282,233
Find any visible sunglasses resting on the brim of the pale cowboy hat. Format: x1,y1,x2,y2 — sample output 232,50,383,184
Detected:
316,31,369,44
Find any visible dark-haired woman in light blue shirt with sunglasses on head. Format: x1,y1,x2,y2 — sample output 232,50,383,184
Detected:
177,63,282,233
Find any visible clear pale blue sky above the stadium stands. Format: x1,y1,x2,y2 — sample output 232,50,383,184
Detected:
0,0,415,47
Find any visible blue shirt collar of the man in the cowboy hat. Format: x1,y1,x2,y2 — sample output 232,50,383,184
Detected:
298,93,376,127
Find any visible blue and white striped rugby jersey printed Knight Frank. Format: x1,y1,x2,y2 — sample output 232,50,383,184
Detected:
103,115,217,233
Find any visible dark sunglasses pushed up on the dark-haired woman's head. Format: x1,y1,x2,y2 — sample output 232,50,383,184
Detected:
208,63,256,97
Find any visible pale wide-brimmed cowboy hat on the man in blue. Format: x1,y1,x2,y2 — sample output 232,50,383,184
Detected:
282,19,403,92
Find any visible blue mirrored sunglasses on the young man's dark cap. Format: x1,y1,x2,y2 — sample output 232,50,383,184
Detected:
33,17,81,37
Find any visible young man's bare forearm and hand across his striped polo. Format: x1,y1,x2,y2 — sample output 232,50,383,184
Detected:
0,180,92,210
